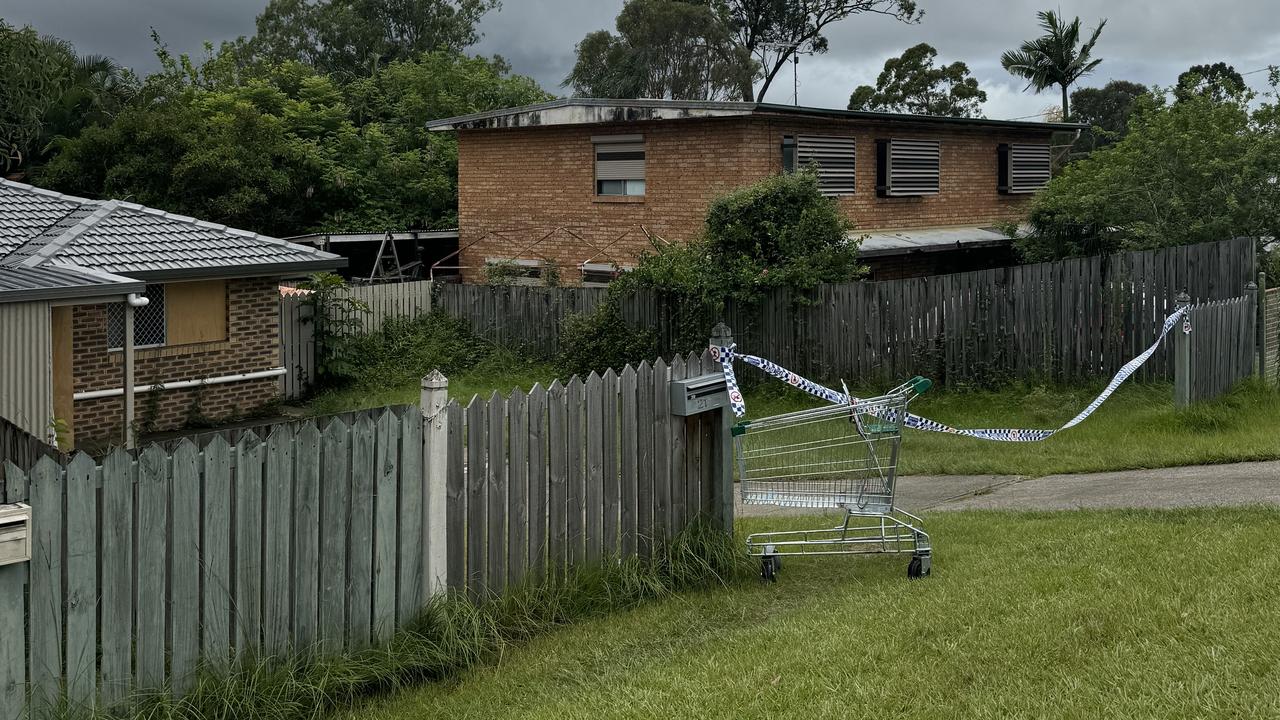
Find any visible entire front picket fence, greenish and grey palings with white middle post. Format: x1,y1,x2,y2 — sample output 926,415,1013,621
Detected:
0,355,732,720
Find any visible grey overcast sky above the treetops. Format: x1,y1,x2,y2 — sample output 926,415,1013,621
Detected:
0,0,1280,118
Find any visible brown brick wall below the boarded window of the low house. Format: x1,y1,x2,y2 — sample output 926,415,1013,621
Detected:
72,278,280,445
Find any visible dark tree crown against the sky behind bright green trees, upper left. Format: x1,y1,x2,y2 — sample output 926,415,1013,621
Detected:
250,0,499,76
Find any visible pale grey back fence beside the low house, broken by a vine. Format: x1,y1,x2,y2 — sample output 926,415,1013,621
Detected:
280,281,431,400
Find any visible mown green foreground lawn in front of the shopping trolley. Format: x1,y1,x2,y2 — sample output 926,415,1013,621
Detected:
337,509,1280,720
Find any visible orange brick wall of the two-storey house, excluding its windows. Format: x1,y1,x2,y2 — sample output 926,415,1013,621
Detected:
458,118,1048,281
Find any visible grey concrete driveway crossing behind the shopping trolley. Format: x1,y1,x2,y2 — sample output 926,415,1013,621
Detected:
735,461,1280,518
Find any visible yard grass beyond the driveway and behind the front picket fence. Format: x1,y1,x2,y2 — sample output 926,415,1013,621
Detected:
302,357,1280,475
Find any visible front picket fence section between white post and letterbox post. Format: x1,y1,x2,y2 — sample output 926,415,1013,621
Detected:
445,352,732,597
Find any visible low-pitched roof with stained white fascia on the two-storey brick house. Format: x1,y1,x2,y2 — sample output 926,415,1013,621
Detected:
426,97,1089,132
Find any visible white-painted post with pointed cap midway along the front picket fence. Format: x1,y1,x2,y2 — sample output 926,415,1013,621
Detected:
419,370,449,597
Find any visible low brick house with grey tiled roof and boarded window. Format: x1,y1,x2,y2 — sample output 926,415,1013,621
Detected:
0,179,346,447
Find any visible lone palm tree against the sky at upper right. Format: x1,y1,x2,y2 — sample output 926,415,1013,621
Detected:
1000,10,1107,120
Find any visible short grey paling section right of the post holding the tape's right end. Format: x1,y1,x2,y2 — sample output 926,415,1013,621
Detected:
1170,292,1258,406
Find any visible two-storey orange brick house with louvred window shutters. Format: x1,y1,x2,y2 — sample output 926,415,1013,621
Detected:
428,99,1083,281
